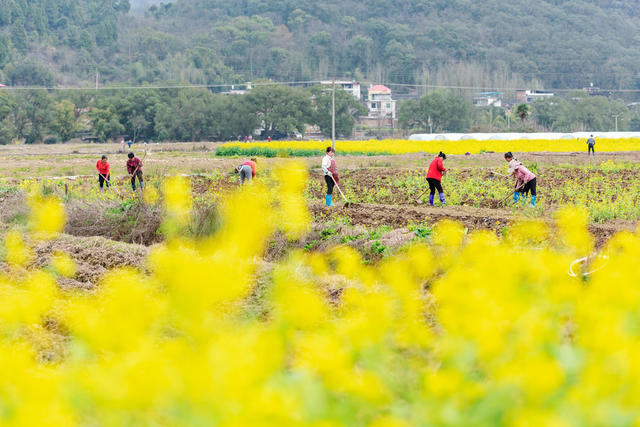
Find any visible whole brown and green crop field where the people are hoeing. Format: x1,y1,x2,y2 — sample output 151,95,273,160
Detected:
0,143,640,289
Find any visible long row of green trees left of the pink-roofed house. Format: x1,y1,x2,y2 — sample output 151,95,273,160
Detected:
0,83,366,144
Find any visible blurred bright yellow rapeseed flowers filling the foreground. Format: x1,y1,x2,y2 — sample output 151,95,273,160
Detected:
0,165,640,426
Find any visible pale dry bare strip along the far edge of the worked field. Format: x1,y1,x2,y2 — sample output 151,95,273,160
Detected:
0,142,640,177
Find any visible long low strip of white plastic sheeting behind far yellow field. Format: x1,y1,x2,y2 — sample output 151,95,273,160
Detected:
409,132,640,141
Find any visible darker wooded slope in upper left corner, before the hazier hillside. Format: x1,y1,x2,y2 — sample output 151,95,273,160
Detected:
0,0,130,85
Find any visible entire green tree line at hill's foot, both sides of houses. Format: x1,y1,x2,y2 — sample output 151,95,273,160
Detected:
0,81,640,144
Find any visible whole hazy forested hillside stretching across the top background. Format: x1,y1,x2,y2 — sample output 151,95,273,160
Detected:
0,0,640,89
